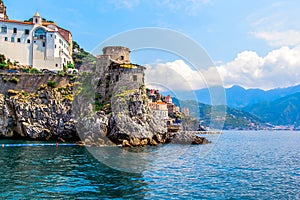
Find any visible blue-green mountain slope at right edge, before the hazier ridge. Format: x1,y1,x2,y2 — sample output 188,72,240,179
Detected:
243,92,300,126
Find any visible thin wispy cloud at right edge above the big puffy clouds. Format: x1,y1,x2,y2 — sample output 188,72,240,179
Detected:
252,30,300,47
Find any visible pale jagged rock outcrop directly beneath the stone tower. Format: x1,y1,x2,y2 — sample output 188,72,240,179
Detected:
108,84,167,146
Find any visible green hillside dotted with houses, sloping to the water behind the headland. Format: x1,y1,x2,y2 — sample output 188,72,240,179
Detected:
173,98,267,129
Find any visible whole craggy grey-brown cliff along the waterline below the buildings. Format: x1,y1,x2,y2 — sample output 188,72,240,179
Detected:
0,72,210,147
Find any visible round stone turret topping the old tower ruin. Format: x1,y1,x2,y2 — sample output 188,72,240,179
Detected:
103,46,130,63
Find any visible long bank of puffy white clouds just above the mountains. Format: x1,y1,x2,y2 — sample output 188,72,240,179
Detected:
146,45,300,91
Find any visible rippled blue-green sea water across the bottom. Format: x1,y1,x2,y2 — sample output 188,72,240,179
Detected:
0,131,300,199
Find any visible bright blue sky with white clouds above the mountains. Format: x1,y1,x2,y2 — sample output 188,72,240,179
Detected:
4,0,300,90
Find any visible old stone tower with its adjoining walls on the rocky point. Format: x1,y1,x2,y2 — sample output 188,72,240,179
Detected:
96,46,146,104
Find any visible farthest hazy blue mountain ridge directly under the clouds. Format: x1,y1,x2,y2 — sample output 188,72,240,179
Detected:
189,85,300,108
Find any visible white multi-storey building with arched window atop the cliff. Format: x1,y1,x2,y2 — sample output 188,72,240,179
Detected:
0,4,73,71
